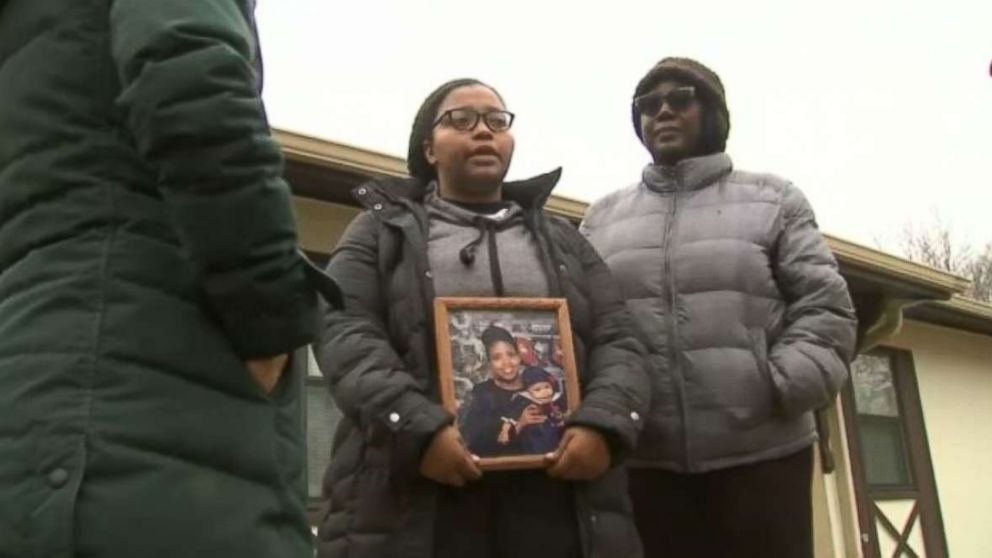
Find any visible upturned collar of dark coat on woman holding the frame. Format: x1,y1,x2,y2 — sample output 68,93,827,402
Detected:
352,168,561,211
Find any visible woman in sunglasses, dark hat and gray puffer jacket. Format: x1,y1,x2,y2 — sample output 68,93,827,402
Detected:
582,58,855,558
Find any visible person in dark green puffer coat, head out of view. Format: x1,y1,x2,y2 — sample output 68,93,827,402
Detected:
0,0,336,558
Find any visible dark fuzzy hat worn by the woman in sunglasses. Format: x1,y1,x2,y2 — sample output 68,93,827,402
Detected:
630,57,730,155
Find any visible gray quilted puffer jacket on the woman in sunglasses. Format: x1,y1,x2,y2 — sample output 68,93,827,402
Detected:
582,153,856,472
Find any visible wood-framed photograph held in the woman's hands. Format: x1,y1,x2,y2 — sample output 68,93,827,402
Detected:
434,297,579,471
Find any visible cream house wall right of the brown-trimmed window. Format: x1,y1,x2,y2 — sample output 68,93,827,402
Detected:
886,322,992,558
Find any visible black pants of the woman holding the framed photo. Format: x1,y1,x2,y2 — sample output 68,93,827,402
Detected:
434,471,582,558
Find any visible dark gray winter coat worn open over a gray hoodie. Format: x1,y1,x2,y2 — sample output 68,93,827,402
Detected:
317,174,650,558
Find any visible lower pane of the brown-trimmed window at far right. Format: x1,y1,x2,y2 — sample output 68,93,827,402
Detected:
858,415,913,487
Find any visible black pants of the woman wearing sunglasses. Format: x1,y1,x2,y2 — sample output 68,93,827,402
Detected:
630,448,813,558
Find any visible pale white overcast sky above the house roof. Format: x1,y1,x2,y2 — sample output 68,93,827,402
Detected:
258,0,992,254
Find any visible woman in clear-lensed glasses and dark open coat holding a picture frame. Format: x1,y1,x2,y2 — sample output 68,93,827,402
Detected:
317,79,650,558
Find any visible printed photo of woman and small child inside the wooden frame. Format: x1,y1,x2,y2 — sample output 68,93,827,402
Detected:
451,312,569,458
